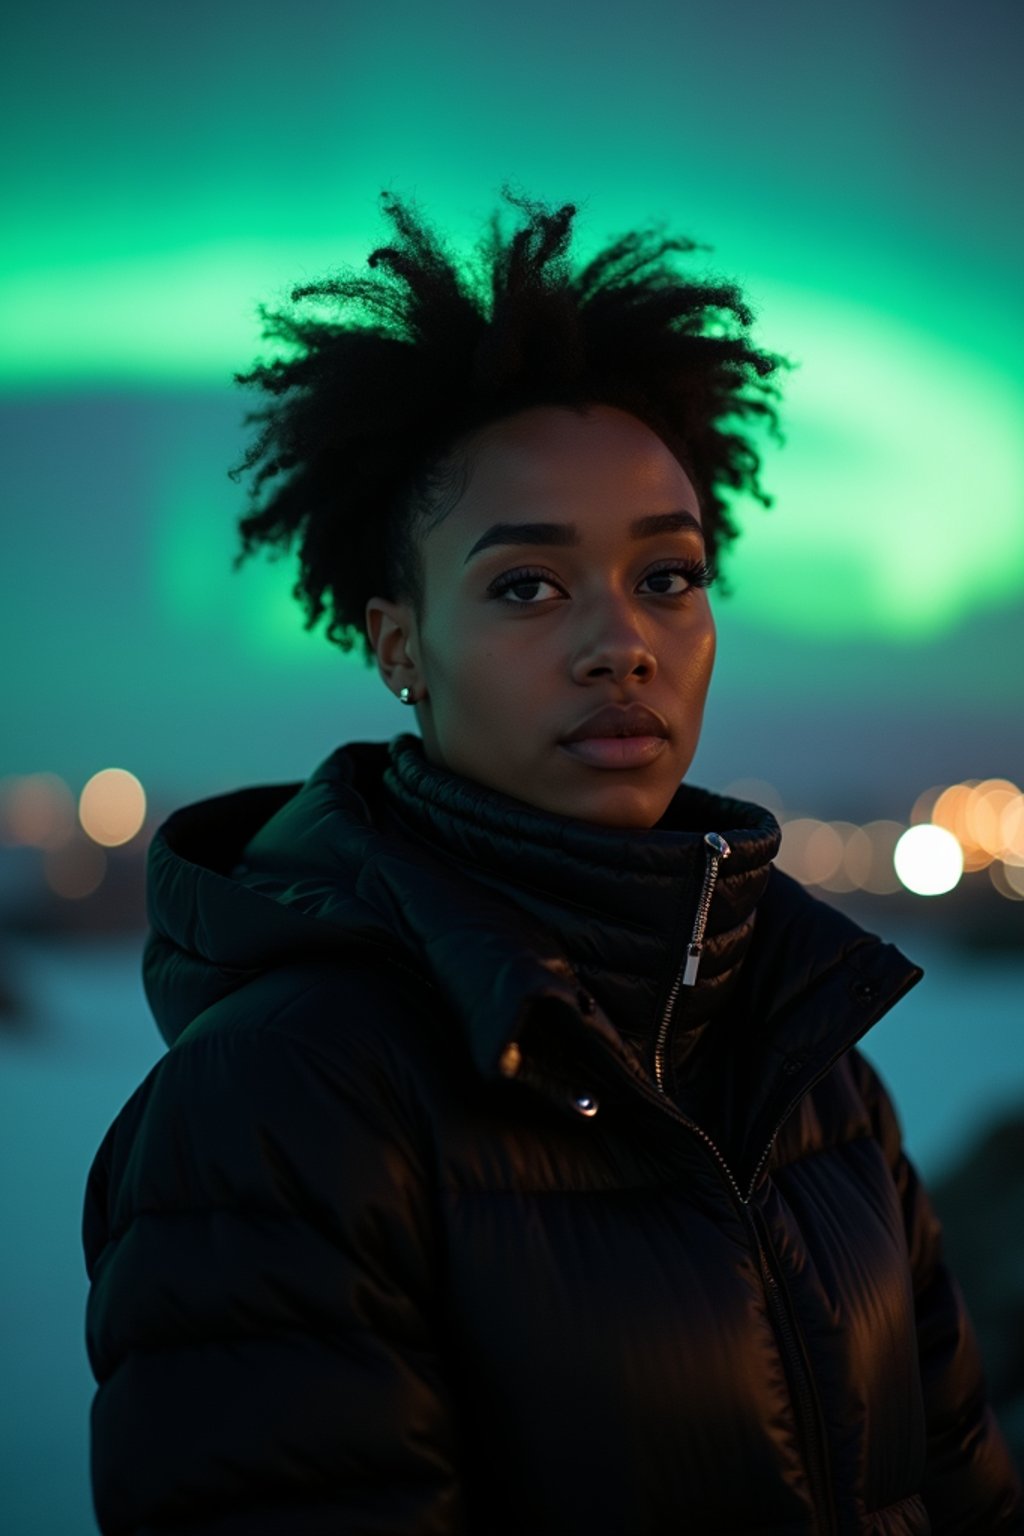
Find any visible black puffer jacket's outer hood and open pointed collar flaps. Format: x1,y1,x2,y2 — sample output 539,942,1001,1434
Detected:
144,742,921,1167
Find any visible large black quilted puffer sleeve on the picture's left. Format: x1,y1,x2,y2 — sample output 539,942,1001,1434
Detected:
83,976,464,1536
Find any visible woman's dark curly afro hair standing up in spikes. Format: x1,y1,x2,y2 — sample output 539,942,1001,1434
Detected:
229,186,789,664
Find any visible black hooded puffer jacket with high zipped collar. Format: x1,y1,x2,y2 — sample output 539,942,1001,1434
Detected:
84,736,1024,1536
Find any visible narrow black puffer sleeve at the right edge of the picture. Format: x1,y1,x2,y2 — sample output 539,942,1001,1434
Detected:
852,1051,1024,1536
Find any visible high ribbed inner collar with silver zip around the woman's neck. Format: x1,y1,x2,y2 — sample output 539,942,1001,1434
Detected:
382,734,780,1091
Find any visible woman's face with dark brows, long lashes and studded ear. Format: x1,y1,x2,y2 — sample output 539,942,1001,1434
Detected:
367,406,715,826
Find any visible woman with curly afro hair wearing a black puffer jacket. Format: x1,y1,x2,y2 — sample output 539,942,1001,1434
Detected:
84,185,1024,1536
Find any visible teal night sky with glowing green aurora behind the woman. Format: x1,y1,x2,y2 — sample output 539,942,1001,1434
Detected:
0,0,1024,811
